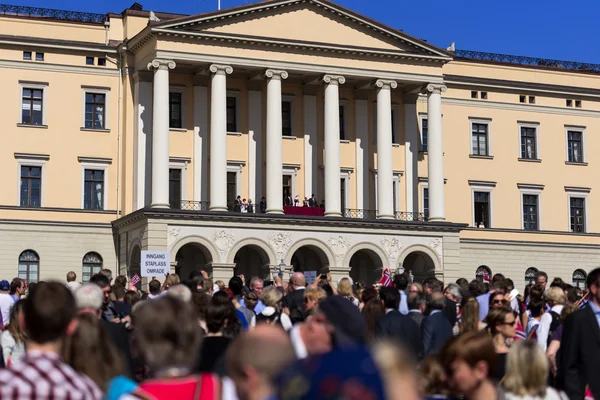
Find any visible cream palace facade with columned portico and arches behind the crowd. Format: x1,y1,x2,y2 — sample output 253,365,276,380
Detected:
0,0,600,288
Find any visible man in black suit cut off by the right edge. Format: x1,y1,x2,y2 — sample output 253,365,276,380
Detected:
557,268,600,400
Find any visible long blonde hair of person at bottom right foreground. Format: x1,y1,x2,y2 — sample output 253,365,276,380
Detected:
504,340,550,397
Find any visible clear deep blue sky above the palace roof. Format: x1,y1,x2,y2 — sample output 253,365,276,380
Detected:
16,0,600,64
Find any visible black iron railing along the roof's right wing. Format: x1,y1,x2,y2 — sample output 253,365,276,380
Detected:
455,50,600,72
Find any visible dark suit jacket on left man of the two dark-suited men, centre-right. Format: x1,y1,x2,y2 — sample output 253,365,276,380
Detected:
375,310,419,359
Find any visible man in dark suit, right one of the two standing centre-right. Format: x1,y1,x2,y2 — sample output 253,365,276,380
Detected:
421,292,453,357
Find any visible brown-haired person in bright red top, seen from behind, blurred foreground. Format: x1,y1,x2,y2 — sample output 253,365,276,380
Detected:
127,296,221,400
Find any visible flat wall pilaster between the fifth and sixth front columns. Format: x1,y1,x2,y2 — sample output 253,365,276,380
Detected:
404,95,419,213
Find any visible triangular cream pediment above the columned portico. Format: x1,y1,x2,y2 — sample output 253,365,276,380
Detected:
154,0,449,58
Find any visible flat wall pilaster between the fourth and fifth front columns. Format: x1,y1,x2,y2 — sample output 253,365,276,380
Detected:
354,99,370,210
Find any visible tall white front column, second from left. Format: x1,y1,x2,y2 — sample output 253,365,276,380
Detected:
210,64,233,211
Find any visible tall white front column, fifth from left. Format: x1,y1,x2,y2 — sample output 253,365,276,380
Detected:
375,79,398,219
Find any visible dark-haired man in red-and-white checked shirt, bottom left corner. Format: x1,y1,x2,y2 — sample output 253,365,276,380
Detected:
0,282,102,400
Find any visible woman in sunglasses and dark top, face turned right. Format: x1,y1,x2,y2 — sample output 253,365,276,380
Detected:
486,307,517,382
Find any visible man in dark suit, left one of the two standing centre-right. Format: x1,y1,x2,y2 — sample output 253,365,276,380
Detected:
375,287,419,359
